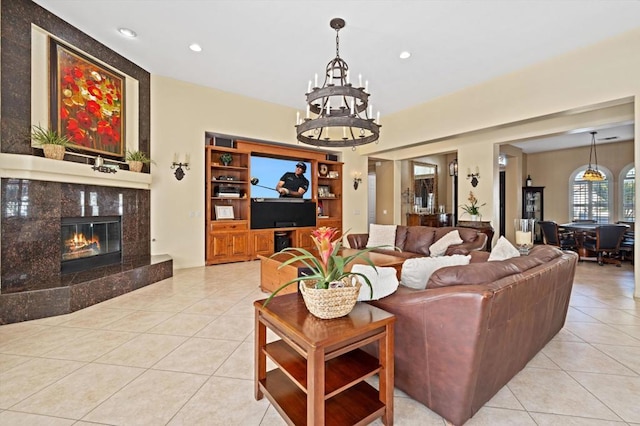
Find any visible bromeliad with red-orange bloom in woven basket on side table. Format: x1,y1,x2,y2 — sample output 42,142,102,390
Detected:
264,226,379,319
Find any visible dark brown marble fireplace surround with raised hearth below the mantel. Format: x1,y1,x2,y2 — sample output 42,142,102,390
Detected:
0,178,173,324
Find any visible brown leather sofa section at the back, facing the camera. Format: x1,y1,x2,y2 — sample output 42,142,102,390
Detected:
347,225,487,259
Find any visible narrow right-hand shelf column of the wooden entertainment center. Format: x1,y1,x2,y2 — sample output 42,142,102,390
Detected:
316,161,343,229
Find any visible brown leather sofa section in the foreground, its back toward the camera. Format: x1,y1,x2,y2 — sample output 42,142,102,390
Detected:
367,246,578,425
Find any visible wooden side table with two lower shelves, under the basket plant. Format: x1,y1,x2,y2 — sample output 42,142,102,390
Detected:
254,294,395,426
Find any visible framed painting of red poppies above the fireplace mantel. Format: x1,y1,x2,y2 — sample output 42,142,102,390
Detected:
50,39,126,158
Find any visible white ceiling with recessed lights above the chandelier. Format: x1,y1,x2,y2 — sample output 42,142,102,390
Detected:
35,0,640,153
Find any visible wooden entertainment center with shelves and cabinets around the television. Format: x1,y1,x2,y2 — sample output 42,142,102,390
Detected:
205,134,343,265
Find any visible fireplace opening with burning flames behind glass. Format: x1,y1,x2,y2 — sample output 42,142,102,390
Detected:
60,216,122,274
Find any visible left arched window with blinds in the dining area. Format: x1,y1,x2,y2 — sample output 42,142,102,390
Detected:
571,170,610,223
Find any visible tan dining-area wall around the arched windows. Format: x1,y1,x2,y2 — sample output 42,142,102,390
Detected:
525,141,634,223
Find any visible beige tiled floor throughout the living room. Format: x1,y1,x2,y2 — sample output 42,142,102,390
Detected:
0,262,640,426
